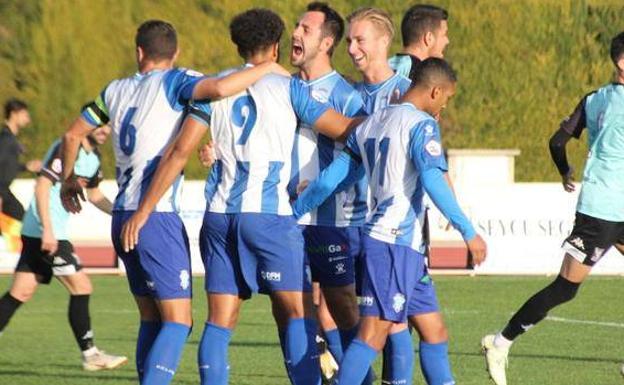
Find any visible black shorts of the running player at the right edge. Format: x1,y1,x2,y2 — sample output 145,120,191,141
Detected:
562,212,624,266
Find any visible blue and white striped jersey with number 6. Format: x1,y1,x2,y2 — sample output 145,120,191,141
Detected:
82,69,201,212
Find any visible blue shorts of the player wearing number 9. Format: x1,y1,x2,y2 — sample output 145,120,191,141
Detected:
199,211,311,298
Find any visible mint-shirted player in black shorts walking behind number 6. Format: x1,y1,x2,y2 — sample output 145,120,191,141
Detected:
0,126,128,371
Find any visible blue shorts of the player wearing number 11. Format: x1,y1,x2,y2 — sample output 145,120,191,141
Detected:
359,235,437,322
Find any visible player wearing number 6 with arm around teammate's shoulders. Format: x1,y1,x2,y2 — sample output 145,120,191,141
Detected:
61,20,288,385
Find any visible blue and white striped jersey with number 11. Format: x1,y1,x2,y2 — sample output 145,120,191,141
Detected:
346,103,447,253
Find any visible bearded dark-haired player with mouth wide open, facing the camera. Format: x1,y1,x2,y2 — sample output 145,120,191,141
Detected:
288,2,367,379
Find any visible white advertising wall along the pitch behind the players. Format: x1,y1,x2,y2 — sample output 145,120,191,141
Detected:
0,180,624,274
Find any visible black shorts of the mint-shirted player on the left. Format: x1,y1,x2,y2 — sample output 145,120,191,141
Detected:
15,235,82,283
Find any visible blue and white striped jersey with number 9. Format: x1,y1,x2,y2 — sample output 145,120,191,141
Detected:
190,70,329,215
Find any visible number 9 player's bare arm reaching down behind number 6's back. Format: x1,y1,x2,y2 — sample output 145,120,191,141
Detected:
121,104,210,252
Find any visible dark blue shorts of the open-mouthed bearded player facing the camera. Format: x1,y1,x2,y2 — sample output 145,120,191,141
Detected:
303,226,361,287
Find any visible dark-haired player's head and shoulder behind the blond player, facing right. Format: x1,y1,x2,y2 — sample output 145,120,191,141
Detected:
390,4,449,79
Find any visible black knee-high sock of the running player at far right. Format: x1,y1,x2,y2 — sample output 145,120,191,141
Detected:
502,275,581,341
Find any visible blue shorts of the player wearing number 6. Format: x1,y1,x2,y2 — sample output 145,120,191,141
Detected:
111,211,192,300
